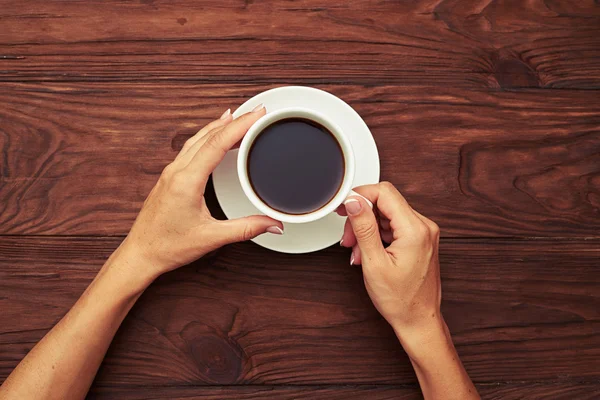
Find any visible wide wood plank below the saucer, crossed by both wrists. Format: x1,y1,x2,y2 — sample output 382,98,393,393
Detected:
0,236,600,386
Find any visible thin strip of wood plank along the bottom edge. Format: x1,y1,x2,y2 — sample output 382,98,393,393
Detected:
89,382,600,400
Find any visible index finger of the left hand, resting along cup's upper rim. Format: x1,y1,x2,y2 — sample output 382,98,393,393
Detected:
188,107,266,184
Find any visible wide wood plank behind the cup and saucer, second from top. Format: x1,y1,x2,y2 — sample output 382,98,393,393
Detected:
0,82,600,237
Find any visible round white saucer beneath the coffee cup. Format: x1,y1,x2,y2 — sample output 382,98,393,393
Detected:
213,86,379,254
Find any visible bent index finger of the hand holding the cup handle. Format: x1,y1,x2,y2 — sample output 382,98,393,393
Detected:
354,182,420,235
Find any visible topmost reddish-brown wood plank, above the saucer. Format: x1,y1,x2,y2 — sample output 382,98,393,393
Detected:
0,0,600,89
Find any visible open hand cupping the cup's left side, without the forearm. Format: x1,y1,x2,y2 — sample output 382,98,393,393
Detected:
119,107,283,279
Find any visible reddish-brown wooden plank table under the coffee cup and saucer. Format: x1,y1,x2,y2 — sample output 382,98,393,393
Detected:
0,0,600,400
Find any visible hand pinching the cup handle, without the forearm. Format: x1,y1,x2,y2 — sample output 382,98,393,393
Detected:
338,182,444,345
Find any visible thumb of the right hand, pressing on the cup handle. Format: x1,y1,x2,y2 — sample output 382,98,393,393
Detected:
344,196,384,263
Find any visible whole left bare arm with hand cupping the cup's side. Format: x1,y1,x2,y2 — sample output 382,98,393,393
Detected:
0,104,283,400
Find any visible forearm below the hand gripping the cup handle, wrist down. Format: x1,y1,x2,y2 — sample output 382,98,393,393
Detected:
396,318,480,400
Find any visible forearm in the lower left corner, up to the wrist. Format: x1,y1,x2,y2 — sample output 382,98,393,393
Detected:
0,245,147,399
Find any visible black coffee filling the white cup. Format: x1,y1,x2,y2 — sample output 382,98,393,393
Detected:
248,118,345,214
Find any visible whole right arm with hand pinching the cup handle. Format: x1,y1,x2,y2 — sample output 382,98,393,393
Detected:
338,182,479,400
